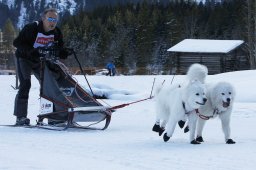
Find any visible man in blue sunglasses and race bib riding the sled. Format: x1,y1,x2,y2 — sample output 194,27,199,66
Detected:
13,8,68,126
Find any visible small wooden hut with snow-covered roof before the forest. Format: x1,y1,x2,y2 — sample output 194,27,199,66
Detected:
167,39,250,74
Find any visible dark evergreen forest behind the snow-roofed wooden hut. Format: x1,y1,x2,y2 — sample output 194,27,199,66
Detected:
2,0,256,74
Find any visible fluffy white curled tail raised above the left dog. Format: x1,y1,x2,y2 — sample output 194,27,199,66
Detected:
187,63,208,83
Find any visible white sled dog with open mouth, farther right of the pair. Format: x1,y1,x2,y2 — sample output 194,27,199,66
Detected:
196,82,235,144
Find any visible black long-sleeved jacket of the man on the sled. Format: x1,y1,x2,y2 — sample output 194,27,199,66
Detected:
13,21,64,60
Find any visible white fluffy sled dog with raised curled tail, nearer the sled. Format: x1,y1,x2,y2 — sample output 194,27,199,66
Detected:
152,64,208,144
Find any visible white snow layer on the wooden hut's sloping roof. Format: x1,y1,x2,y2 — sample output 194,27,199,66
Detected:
167,39,244,53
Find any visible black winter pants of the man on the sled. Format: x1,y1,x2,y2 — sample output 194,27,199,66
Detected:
14,58,40,117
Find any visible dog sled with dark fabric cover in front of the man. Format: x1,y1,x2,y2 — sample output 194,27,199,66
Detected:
34,46,111,130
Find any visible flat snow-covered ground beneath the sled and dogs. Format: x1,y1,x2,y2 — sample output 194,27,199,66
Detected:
0,70,256,170
